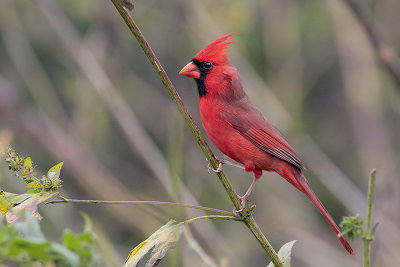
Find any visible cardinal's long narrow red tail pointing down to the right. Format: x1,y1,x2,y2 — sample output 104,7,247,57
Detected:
296,172,354,255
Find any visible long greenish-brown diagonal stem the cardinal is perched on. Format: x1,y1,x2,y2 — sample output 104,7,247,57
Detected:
111,0,283,267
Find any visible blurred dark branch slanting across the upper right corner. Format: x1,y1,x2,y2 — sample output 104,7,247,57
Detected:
344,0,400,88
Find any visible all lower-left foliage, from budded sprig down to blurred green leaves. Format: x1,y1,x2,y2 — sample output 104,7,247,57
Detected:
0,150,100,267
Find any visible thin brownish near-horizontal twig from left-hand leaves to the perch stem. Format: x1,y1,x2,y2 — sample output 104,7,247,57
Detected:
46,197,232,215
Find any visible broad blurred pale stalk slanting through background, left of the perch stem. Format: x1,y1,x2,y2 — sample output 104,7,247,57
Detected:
36,0,241,264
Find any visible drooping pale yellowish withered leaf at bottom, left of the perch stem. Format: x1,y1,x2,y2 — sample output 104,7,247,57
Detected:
124,220,184,267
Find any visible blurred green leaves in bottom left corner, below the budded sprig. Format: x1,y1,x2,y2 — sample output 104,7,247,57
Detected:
0,213,99,267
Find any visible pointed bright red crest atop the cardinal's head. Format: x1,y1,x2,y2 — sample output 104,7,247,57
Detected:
194,33,235,62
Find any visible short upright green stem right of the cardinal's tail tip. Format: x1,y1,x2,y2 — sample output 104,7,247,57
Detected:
363,170,377,267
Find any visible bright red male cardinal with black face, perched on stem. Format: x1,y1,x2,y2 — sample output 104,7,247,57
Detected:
179,33,354,254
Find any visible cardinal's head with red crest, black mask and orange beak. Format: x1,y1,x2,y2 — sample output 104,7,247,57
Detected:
179,33,236,96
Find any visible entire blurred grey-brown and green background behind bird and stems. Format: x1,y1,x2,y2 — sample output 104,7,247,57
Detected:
0,0,400,267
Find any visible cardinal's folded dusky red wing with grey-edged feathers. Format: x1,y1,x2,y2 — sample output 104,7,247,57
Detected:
226,116,305,170
